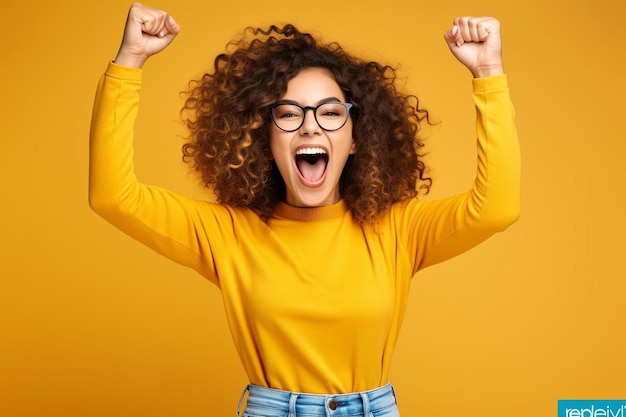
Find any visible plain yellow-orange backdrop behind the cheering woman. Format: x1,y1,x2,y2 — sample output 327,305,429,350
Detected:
0,0,626,417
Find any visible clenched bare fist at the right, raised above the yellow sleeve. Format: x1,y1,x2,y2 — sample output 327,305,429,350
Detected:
444,16,504,78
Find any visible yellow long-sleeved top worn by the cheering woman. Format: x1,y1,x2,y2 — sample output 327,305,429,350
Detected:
89,63,520,394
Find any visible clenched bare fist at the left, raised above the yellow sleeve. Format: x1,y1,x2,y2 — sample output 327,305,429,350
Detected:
115,3,180,68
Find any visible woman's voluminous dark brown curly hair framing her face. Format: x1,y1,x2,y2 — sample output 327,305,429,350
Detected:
181,24,432,224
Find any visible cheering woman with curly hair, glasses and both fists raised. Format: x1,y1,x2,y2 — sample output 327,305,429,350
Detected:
89,4,519,417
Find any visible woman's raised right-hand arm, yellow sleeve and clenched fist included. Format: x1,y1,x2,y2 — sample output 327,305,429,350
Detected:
400,17,520,271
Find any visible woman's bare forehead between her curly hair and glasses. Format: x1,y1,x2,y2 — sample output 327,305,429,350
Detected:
282,68,345,104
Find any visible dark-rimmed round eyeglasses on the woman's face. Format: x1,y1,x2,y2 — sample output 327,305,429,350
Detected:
270,101,352,132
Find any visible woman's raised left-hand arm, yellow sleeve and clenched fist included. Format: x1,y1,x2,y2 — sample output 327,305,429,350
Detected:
89,4,224,282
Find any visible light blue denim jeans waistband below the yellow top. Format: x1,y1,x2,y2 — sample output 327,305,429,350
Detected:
237,384,400,417
